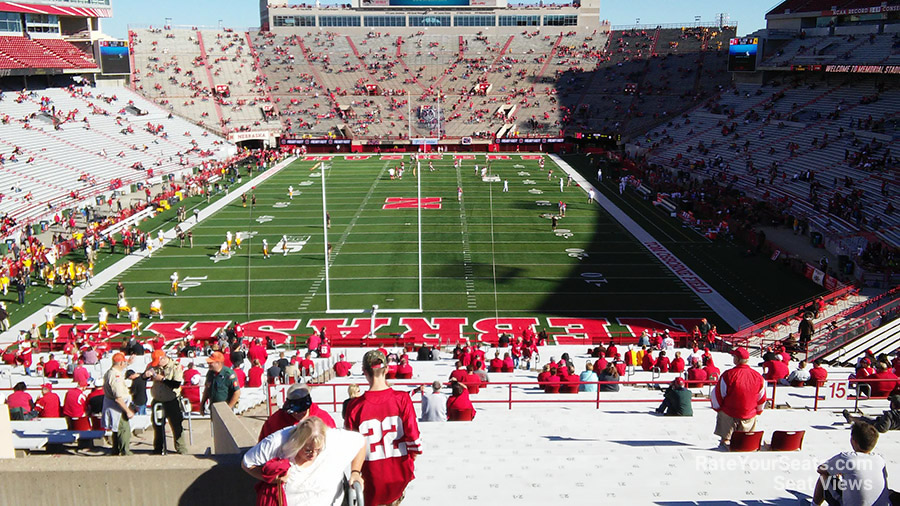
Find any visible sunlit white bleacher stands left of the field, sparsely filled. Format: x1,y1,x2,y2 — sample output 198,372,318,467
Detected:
0,87,224,227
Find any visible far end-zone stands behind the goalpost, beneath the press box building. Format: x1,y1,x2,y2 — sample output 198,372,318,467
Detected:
131,28,734,139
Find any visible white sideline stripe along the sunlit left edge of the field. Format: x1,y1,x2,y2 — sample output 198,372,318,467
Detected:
0,156,298,346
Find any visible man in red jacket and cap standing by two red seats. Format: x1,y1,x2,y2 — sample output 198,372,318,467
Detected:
710,348,766,447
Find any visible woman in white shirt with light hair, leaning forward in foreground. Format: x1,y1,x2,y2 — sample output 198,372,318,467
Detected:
242,417,366,506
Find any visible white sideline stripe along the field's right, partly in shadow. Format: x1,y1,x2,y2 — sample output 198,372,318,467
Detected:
549,154,751,329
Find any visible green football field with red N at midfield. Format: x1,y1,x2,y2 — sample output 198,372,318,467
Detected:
81,154,724,333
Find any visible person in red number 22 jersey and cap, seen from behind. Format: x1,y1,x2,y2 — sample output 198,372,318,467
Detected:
345,350,422,506
